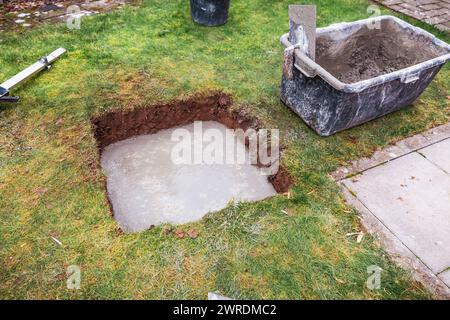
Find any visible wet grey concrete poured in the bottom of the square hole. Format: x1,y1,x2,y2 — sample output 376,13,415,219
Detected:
101,121,276,232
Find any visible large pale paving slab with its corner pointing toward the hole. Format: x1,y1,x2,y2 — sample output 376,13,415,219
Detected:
343,152,450,273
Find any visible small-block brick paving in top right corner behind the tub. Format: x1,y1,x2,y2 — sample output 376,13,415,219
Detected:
376,0,450,32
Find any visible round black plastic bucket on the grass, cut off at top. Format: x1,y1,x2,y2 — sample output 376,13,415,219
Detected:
191,0,230,27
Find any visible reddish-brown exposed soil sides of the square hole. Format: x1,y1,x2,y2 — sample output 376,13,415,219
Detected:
92,92,293,193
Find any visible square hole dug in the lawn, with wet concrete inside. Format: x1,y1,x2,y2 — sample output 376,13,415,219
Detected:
93,93,292,232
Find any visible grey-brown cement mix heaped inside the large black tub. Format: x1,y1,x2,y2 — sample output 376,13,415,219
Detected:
316,20,448,83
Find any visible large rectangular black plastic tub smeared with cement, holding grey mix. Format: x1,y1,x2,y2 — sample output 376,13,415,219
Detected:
281,16,450,136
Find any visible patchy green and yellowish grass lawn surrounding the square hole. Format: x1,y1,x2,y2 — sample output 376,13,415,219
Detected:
0,0,450,299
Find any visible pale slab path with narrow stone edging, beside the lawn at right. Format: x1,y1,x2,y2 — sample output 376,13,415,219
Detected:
333,125,450,298
